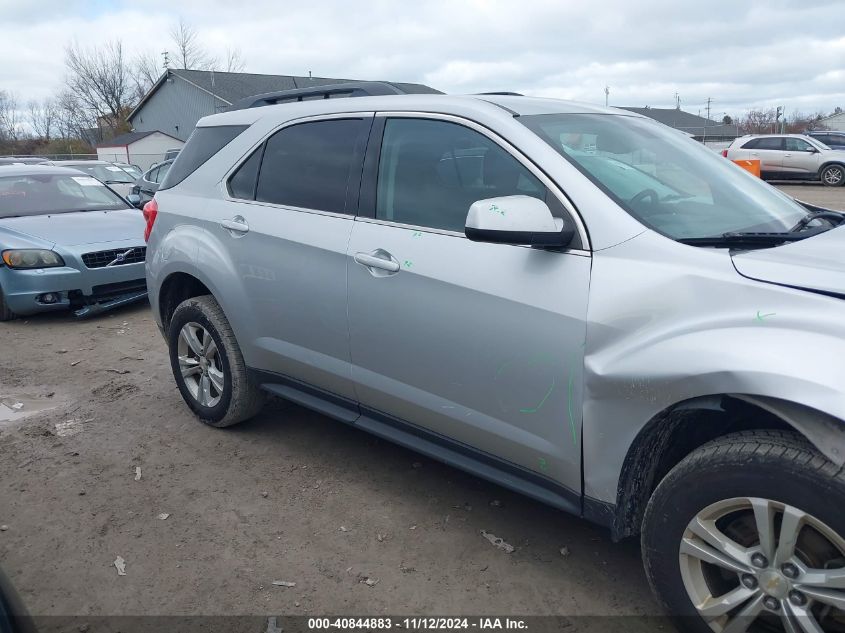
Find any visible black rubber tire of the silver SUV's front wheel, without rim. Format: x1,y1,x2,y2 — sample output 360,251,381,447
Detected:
642,431,845,633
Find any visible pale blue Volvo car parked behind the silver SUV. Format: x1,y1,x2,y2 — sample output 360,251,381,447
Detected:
0,165,147,321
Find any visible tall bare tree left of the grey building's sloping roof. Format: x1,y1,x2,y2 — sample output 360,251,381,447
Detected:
65,41,135,133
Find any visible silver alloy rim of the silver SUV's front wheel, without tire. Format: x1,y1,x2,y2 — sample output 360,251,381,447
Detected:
679,497,845,633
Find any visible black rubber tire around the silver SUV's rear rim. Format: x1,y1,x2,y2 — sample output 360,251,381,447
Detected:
167,295,267,427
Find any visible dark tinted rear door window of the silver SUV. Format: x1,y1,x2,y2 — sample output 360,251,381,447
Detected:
255,119,366,213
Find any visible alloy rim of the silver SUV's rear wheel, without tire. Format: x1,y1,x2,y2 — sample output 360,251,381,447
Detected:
177,321,226,407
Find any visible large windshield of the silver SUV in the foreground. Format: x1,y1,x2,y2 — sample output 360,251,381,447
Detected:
517,114,808,239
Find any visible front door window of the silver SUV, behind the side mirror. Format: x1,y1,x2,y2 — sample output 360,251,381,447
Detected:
376,118,548,233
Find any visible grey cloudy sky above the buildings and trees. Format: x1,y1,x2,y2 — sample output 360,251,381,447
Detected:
0,0,845,118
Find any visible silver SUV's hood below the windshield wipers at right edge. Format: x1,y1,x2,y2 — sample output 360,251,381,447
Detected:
732,226,845,296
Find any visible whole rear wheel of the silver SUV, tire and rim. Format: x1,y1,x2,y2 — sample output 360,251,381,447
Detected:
167,295,266,427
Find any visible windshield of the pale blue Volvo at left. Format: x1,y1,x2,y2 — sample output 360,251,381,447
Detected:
0,174,130,218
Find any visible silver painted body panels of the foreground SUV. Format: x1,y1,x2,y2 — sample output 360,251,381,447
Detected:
147,95,845,520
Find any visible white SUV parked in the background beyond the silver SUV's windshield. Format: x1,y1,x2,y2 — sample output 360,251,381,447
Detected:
722,134,845,187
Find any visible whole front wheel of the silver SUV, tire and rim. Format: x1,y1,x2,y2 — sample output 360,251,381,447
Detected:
642,431,845,633
